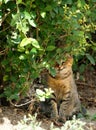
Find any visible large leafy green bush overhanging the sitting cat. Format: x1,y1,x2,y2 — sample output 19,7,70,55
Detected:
0,0,96,100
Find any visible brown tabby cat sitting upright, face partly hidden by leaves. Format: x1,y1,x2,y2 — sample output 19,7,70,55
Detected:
47,57,81,122
